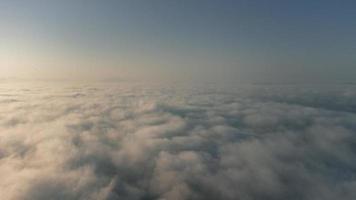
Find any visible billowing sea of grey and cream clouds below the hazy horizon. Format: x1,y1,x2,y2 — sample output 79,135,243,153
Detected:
0,81,356,200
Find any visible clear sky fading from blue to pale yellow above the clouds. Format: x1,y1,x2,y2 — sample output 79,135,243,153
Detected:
0,0,356,82
